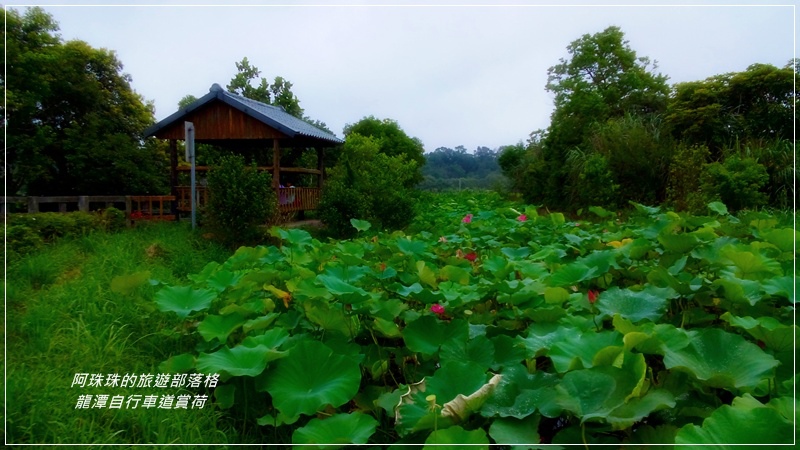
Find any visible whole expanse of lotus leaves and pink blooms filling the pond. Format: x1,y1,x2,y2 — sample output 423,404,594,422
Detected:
148,192,798,447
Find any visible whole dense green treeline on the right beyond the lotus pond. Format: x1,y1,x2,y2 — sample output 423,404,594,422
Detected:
499,27,797,211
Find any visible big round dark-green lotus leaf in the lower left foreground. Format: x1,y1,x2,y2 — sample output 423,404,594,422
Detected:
266,341,361,417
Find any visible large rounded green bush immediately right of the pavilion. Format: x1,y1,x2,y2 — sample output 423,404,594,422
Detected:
318,134,418,236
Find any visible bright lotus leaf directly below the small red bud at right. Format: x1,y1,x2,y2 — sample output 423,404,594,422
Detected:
547,331,623,373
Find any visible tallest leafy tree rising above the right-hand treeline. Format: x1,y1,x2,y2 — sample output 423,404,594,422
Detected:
526,26,669,208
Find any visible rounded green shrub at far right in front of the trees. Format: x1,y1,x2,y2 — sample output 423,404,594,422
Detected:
702,156,769,211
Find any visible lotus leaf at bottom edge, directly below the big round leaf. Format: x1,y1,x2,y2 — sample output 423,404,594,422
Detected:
292,413,378,449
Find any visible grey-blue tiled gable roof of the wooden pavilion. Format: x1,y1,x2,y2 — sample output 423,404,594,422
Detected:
145,83,344,144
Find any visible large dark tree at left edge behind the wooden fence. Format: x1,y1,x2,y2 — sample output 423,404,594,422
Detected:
2,8,169,195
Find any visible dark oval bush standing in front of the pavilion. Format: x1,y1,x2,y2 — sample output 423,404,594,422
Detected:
206,155,278,246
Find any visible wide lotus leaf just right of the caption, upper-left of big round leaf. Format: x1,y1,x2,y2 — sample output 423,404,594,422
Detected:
196,345,285,377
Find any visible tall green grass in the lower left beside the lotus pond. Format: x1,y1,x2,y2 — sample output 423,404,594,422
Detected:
5,223,276,444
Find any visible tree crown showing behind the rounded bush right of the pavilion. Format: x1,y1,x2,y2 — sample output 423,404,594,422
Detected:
344,116,425,187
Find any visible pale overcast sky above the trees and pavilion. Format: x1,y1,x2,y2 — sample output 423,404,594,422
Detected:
8,0,796,151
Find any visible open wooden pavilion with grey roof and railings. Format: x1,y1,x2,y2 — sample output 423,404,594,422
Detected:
145,83,344,219
